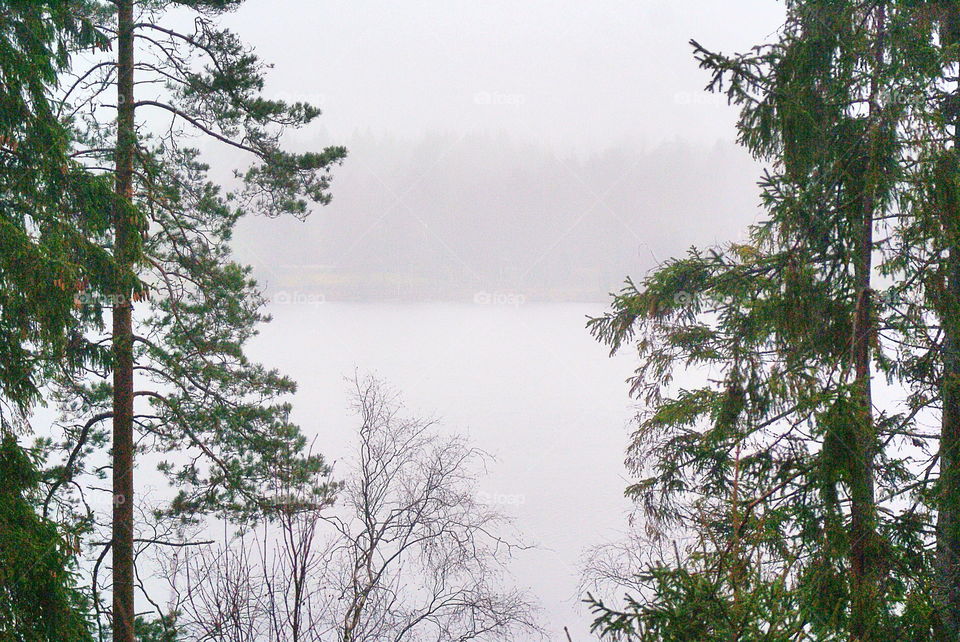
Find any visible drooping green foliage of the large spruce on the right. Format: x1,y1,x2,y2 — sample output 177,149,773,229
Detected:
589,0,958,640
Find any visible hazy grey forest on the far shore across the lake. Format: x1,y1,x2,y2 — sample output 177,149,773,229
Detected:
236,135,758,303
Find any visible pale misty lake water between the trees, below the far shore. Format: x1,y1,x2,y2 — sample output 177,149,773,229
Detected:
253,301,633,639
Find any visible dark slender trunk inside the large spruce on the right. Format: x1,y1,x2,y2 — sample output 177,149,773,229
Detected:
849,3,886,642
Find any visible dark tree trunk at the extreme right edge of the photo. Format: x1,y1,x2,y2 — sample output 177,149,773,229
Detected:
936,8,960,641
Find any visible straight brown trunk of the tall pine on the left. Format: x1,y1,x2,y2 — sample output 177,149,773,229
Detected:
112,0,137,642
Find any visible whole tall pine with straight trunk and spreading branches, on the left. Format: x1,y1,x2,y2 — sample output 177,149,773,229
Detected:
42,0,345,641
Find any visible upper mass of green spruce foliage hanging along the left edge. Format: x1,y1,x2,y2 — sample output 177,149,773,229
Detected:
0,1,113,411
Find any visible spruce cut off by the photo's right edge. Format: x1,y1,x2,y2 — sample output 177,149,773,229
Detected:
891,0,960,640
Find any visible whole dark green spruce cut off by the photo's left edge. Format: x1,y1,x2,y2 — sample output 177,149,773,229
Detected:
0,0,124,641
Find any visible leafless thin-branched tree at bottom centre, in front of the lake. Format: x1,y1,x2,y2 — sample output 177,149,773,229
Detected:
326,378,539,642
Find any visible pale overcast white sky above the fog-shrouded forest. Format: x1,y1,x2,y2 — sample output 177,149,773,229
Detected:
226,0,783,151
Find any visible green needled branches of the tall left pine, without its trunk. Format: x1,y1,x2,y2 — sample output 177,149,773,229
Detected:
33,0,346,637
